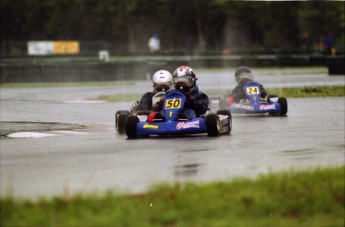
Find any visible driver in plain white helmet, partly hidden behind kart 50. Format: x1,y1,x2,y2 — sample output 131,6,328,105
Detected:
138,70,174,111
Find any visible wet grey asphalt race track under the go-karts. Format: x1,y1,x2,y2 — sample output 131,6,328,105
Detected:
0,69,345,198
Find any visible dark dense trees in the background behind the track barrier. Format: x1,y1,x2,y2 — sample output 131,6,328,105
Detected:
1,0,345,54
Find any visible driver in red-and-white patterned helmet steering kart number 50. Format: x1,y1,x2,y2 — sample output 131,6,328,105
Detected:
153,66,209,120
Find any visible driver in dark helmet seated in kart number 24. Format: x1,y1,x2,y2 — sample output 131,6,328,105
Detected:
227,66,267,104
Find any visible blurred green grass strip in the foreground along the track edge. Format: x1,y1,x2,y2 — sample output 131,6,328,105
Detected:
0,166,345,227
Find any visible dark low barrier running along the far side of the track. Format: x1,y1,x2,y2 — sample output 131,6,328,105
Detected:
0,55,345,83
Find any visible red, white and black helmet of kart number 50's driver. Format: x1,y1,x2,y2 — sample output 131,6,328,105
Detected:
173,66,197,92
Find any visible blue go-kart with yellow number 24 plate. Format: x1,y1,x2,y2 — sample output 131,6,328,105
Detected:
222,81,288,116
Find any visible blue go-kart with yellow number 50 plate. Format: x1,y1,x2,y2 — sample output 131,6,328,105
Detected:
126,90,232,138
